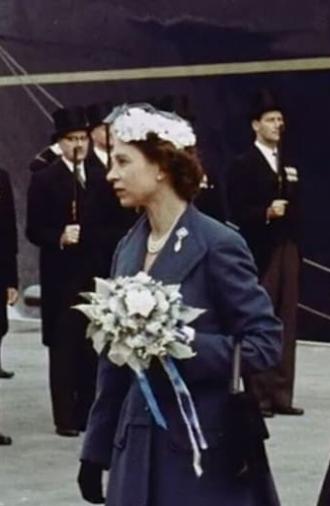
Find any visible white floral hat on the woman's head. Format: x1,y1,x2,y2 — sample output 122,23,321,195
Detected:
104,104,196,149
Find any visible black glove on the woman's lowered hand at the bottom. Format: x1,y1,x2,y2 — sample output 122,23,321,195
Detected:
78,460,105,504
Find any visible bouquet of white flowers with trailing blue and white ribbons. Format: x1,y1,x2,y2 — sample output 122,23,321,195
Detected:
76,272,207,476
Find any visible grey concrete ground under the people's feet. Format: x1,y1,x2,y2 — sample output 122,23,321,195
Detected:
0,322,330,506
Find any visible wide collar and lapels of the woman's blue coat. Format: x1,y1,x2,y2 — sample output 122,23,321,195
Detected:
115,204,207,284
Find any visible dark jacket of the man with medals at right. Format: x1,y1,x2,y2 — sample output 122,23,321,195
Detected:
227,146,299,273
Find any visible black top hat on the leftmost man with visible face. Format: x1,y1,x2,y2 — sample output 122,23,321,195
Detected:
52,106,89,142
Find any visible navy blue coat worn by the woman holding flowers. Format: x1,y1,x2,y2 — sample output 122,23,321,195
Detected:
82,206,281,506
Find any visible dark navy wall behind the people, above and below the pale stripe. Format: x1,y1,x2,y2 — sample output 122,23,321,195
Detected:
0,0,330,340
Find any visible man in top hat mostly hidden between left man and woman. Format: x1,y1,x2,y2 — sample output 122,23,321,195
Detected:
86,102,137,257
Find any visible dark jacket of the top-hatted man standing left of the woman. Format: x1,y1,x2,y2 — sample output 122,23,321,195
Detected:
27,159,118,344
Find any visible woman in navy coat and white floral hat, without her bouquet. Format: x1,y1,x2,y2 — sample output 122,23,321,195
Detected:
78,106,281,506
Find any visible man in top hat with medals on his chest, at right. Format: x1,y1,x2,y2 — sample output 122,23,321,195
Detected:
227,90,303,416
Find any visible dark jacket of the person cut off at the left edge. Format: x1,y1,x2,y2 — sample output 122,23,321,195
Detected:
0,169,18,337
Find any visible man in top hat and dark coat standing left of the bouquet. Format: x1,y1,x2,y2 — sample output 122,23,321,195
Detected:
27,107,115,436
